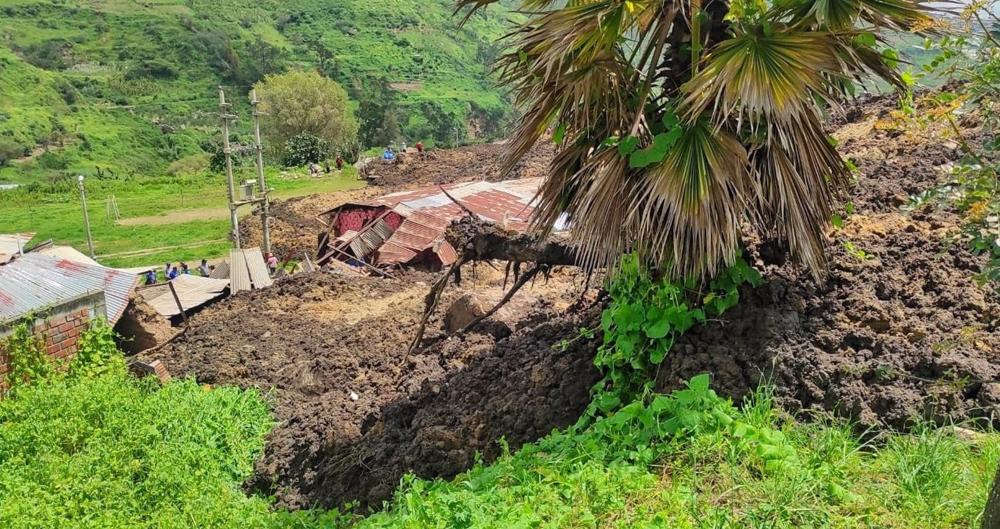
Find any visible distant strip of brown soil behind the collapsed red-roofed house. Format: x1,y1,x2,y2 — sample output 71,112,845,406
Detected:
367,140,555,187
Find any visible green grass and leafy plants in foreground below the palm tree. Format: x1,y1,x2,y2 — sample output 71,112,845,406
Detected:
357,384,1000,529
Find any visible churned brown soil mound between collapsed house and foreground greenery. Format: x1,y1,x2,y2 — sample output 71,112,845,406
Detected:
147,267,599,507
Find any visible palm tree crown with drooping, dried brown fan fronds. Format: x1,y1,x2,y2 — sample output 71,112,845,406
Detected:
458,0,932,277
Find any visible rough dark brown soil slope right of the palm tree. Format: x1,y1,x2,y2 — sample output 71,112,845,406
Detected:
658,93,1000,427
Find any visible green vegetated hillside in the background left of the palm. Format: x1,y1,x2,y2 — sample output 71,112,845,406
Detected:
0,0,510,183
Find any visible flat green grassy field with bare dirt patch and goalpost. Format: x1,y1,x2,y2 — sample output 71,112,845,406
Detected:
0,169,363,267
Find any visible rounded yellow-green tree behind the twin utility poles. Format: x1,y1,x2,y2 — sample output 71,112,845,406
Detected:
255,72,358,159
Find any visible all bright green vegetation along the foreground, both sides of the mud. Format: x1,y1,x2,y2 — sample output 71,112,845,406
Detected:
0,358,1000,529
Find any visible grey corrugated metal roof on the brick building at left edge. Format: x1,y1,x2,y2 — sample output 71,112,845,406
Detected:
0,253,139,325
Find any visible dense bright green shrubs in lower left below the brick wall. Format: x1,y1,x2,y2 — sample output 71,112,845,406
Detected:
0,360,338,529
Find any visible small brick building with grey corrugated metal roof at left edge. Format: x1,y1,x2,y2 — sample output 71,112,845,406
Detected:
0,252,139,381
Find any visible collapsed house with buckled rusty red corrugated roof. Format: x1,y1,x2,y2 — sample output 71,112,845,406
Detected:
316,178,542,270
